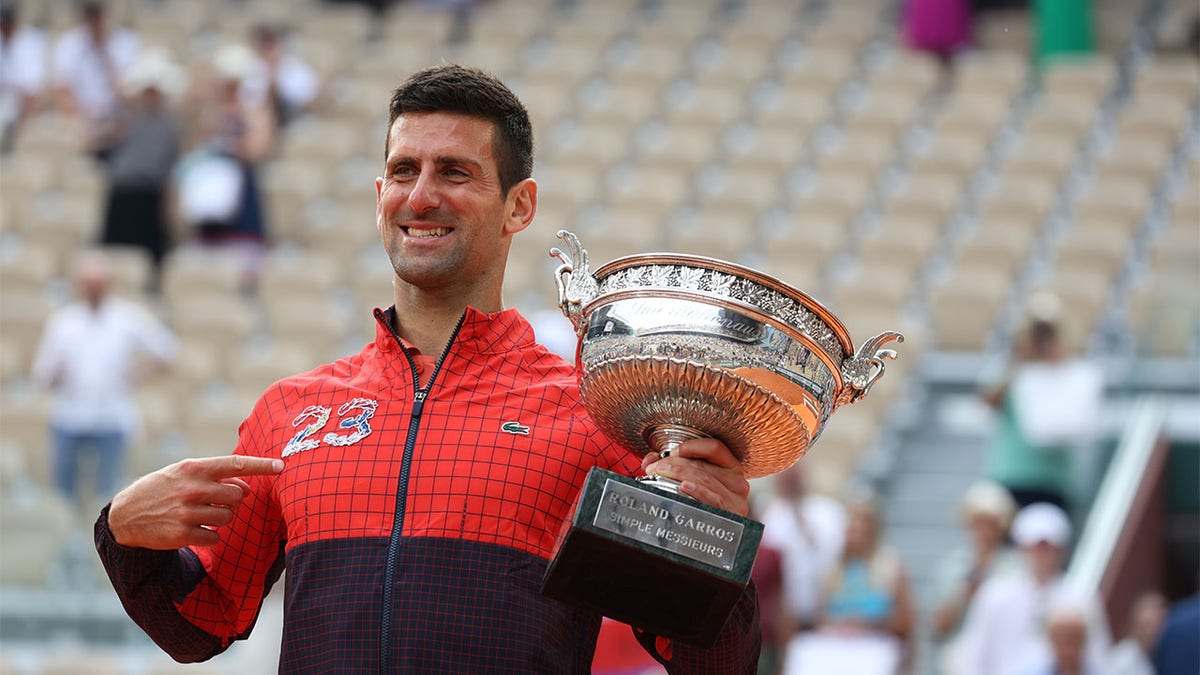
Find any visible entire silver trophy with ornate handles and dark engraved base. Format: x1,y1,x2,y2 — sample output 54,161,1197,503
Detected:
544,231,904,644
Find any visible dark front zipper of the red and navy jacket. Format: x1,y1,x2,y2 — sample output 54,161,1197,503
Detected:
379,309,467,673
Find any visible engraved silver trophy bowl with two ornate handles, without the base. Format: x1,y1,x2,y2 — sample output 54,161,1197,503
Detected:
551,232,904,480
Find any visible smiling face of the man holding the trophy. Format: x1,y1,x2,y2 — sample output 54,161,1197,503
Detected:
376,113,532,291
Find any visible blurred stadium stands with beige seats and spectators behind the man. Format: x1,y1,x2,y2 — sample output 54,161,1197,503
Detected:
0,0,1200,675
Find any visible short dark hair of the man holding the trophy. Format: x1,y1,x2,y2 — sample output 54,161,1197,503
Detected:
384,64,533,195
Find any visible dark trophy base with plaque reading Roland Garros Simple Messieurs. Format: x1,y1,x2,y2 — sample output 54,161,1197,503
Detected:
541,468,762,647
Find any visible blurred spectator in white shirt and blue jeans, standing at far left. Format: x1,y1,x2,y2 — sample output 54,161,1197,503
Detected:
32,251,176,500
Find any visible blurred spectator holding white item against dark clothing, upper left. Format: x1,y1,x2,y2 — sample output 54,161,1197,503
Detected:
176,44,275,285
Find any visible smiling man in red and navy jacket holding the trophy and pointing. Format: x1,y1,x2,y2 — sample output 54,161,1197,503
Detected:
96,66,761,674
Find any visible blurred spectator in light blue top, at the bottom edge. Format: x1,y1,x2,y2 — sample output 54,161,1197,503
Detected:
784,501,913,675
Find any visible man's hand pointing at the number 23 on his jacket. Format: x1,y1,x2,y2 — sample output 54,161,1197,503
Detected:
108,455,283,550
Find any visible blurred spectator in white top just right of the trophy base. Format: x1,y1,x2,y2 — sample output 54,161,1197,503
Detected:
762,462,846,634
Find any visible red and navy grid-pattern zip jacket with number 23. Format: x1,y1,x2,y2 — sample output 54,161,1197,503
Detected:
96,309,760,674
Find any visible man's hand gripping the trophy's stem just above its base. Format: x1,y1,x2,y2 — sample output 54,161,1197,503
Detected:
642,438,750,515
